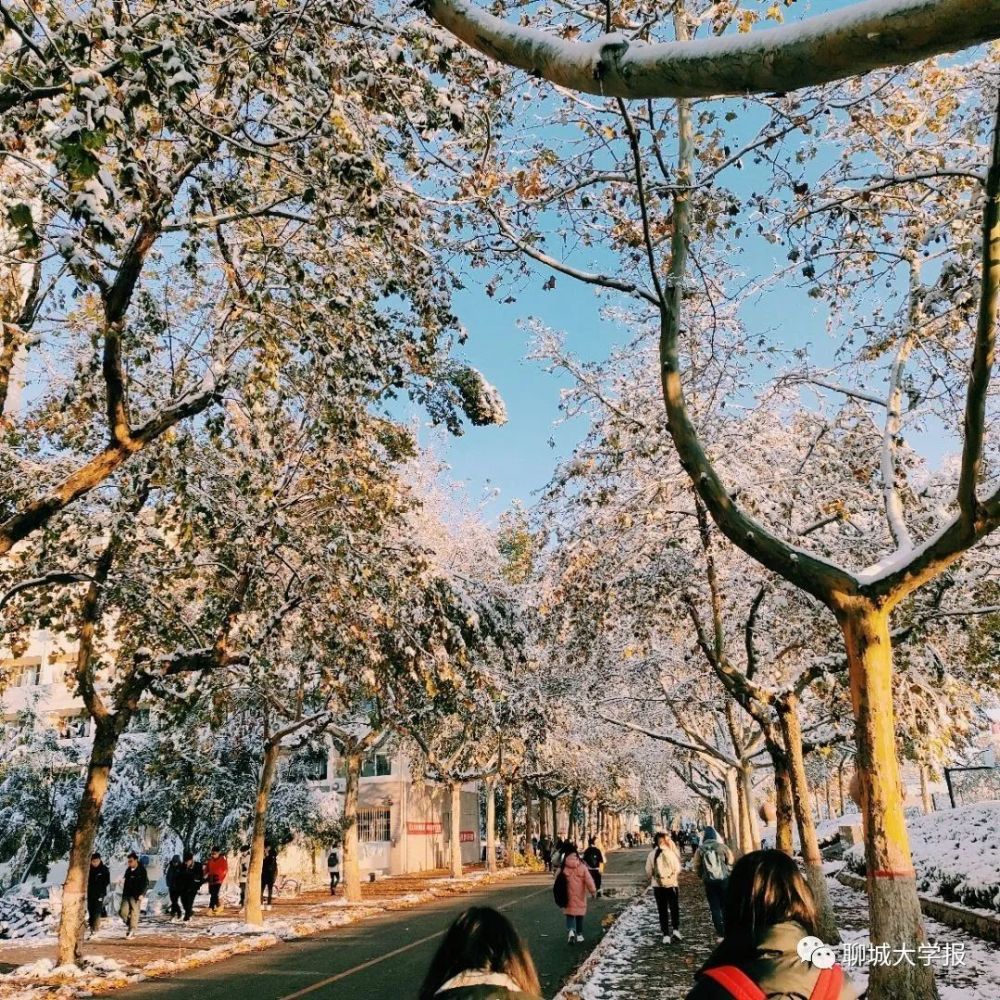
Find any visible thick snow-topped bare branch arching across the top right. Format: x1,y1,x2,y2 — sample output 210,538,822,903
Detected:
420,0,1000,98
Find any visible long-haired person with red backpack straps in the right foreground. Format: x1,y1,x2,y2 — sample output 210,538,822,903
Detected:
687,850,858,1000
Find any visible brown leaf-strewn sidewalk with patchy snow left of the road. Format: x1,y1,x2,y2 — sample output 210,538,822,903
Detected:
0,864,518,1000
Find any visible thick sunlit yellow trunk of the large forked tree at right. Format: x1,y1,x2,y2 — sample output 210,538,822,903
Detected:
839,602,935,1000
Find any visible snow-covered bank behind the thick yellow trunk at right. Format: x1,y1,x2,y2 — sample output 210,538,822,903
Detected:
844,802,1000,912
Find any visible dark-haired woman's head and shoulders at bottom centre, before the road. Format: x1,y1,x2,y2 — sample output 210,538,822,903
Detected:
419,906,542,1000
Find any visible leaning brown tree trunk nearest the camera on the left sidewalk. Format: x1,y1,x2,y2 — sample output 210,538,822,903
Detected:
56,719,118,965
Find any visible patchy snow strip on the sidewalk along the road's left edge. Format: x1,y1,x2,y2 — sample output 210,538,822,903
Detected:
0,868,518,1000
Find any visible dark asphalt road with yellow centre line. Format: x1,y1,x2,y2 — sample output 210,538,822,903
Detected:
125,850,646,1000
